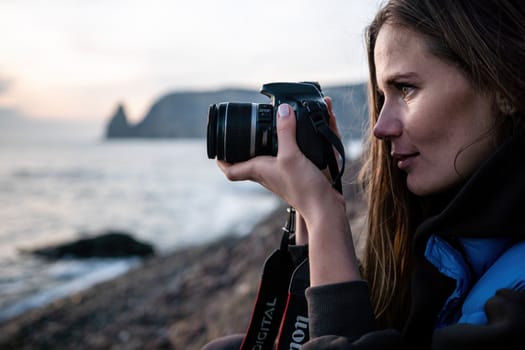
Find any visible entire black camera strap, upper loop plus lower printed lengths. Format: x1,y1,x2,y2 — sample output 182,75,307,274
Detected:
240,101,345,350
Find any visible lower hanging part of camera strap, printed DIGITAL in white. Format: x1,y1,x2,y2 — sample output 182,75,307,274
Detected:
240,208,310,350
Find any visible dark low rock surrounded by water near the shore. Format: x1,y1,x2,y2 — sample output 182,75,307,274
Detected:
31,231,154,259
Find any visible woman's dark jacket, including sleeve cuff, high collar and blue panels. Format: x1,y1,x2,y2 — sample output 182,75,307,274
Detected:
302,136,525,350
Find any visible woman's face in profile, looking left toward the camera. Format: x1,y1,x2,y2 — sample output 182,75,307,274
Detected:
374,24,496,196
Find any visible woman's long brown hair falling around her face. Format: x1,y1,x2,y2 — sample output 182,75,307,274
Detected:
361,0,525,327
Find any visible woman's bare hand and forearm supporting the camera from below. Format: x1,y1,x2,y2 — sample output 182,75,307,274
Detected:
218,99,360,286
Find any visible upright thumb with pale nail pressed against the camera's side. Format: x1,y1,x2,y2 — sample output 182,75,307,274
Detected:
277,103,298,158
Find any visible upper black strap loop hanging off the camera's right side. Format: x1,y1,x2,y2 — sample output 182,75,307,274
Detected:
302,101,346,193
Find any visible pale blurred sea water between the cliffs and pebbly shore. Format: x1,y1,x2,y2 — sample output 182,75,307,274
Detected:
0,120,280,322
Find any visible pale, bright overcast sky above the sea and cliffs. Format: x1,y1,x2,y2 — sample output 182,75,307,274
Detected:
0,0,382,121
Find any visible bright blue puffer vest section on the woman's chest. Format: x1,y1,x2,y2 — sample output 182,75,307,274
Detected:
425,235,525,328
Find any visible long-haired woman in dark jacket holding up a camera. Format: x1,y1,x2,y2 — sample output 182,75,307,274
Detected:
203,0,525,349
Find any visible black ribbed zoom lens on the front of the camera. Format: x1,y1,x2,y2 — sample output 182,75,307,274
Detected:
207,102,277,163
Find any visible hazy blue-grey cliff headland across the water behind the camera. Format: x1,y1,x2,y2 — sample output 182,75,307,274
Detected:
106,84,368,139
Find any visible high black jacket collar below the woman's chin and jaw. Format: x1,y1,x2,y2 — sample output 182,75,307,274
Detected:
414,134,525,252
